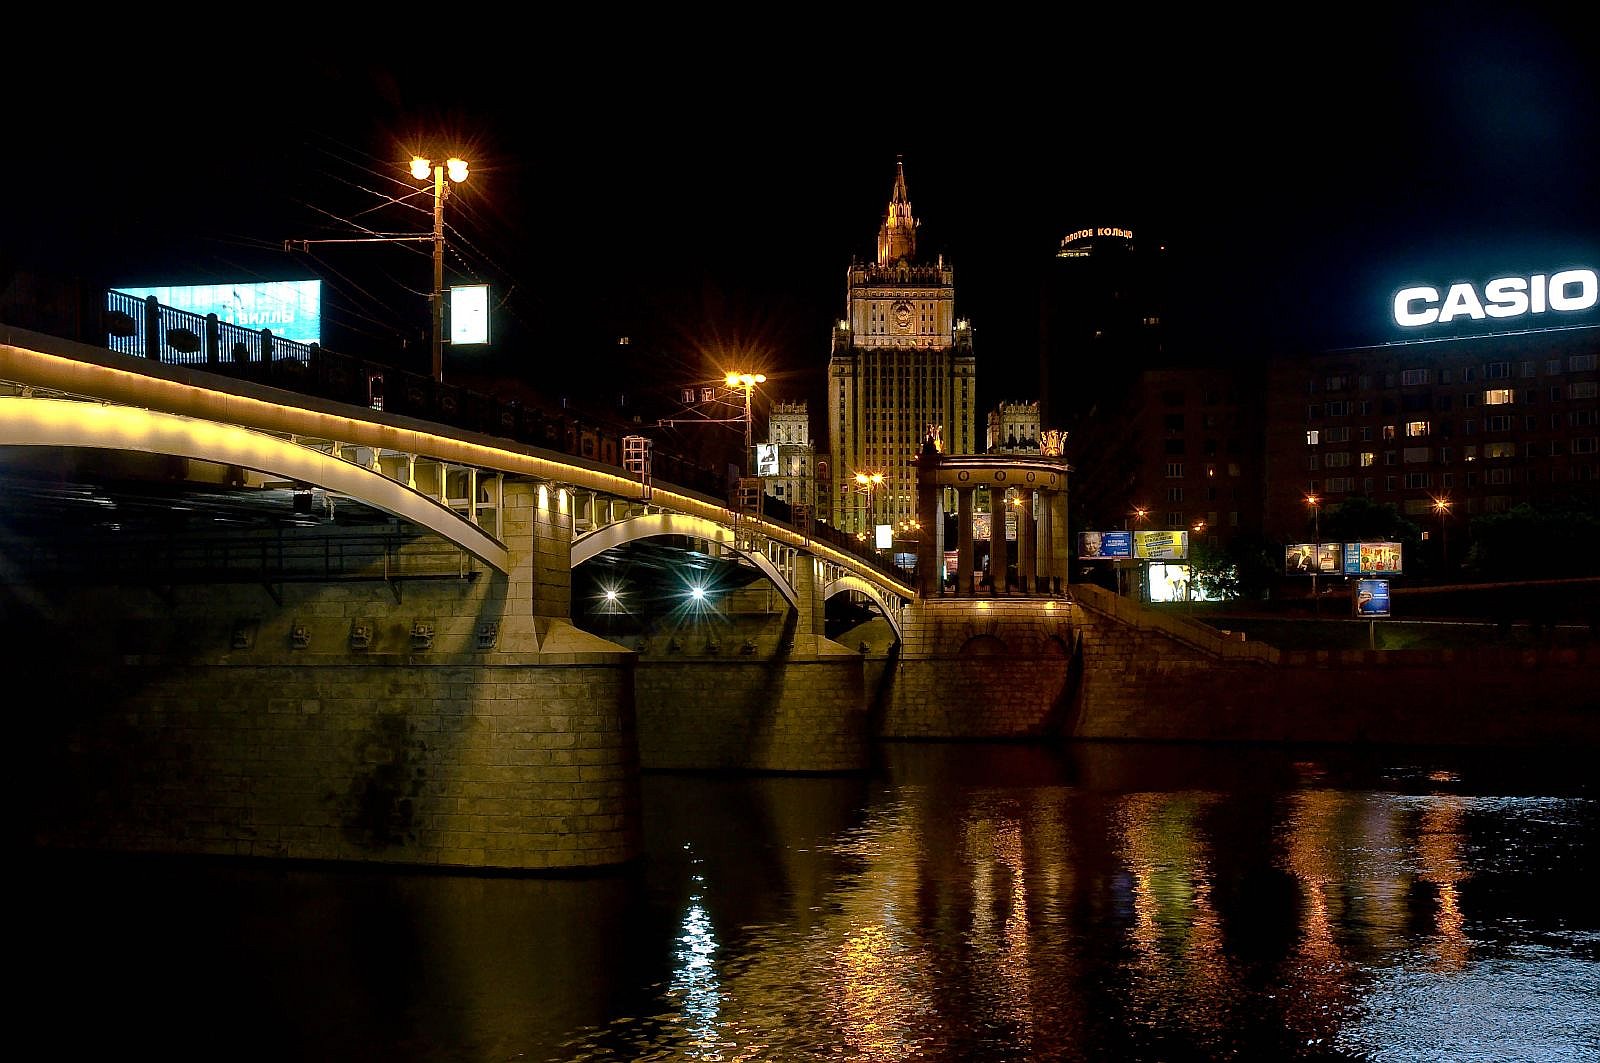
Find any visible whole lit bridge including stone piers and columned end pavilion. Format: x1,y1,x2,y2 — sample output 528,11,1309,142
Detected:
0,306,1100,868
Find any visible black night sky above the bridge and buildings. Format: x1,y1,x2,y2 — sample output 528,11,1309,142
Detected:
0,5,1600,429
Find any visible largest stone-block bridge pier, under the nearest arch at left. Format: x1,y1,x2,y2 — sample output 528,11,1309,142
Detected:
12,575,640,869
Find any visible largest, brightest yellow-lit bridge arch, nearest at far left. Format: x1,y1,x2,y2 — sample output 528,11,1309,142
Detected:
0,397,510,572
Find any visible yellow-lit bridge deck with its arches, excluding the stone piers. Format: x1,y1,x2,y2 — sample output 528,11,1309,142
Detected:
0,312,915,632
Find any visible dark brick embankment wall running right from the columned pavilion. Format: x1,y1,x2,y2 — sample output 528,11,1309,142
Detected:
1066,588,1600,746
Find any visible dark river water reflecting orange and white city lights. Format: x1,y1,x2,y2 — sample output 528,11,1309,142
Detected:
11,744,1600,1061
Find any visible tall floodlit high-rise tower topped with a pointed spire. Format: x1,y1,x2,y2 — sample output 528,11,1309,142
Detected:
827,160,979,532
